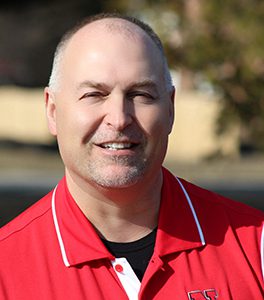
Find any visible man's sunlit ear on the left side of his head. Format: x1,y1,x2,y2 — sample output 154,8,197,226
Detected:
44,87,57,136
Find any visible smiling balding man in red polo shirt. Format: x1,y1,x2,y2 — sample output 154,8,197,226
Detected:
0,15,264,300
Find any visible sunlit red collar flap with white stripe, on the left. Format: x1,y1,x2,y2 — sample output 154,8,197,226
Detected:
52,177,114,267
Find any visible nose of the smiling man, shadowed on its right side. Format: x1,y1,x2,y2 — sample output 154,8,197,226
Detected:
104,95,133,131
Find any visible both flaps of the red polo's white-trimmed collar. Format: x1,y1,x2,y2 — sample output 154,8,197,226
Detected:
52,169,205,267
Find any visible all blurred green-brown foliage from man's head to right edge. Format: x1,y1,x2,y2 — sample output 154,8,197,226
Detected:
110,0,264,151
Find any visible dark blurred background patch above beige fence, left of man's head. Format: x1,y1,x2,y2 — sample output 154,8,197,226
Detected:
0,0,106,87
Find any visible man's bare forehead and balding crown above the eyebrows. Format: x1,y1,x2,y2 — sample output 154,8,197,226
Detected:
59,19,163,88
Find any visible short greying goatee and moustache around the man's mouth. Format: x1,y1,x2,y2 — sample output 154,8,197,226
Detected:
78,130,148,188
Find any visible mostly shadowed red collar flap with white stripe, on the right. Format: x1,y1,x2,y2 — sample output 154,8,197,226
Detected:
155,169,205,256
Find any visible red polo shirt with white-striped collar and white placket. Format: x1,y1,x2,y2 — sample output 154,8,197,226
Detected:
0,170,264,300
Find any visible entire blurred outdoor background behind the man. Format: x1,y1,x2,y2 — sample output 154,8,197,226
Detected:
0,0,264,225
